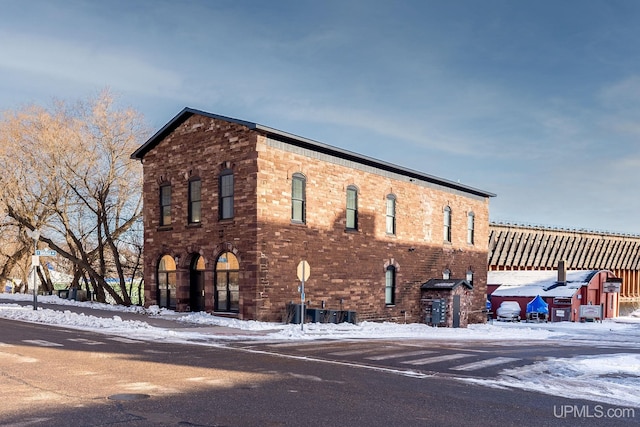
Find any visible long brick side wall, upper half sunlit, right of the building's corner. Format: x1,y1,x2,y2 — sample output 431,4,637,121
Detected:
252,137,488,322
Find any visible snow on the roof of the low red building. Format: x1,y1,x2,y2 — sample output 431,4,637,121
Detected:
487,270,597,298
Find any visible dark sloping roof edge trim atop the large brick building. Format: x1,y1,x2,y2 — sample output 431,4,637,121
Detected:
131,108,496,197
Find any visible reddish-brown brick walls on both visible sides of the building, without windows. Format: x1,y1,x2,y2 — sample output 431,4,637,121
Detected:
143,115,489,322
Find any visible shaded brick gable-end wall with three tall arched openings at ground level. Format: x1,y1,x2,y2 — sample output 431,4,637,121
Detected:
143,115,256,317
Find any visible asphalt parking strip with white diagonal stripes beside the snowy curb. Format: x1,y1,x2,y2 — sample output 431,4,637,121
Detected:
229,339,640,378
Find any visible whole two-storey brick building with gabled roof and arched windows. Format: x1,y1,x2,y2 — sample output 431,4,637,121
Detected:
132,109,494,322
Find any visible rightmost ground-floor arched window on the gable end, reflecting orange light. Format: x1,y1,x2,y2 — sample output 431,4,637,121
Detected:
213,252,240,313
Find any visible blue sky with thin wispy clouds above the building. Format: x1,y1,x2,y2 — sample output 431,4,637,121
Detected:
0,0,640,233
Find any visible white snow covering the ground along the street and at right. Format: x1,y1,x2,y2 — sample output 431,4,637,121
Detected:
0,293,640,417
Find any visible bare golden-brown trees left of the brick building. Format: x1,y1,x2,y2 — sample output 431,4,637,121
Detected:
0,91,148,305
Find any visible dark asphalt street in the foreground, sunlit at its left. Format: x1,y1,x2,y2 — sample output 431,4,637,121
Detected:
0,319,640,426
